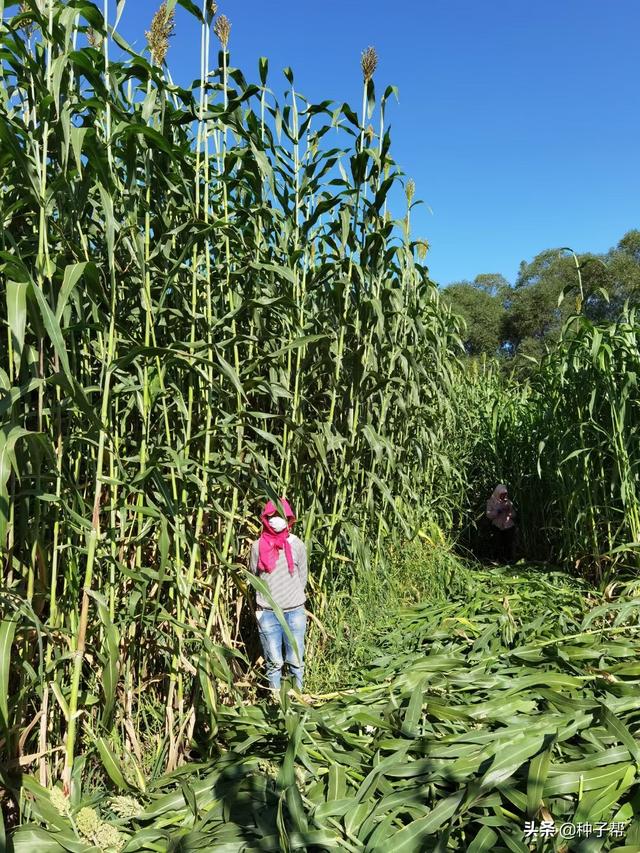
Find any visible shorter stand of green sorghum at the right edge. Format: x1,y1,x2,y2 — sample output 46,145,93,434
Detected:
464,308,640,582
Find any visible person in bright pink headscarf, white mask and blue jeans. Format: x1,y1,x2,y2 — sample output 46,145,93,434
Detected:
249,498,307,690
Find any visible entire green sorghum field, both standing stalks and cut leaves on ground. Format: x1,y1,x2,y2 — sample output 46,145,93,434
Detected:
0,0,640,853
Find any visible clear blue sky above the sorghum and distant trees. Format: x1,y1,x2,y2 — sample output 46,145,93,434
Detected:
119,0,640,284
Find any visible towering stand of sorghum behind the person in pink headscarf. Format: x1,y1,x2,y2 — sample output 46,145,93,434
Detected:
0,0,462,791
